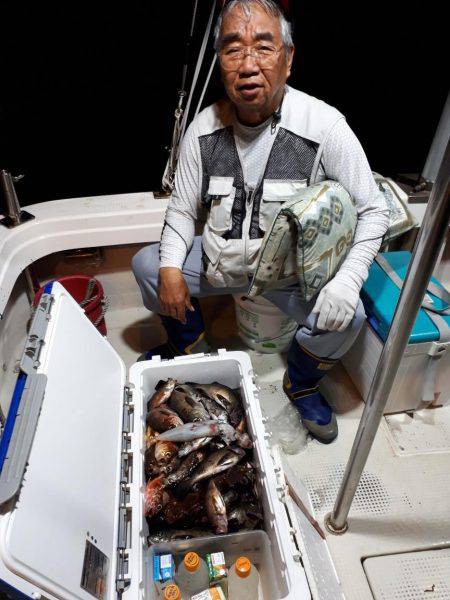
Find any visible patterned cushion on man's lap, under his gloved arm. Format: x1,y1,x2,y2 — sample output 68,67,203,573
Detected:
248,181,358,301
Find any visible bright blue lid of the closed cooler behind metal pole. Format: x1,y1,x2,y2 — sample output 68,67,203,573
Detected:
361,251,450,344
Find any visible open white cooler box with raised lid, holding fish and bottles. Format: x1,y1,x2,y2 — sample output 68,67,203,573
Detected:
0,283,310,600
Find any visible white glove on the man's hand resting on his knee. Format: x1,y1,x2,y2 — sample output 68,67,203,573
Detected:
312,277,359,331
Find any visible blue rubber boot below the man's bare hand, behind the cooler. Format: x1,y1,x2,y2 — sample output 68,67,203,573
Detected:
138,298,210,361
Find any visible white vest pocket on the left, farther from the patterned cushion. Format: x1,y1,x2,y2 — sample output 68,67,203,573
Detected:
207,175,236,234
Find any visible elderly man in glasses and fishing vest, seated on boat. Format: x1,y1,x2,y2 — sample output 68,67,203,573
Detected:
133,0,389,443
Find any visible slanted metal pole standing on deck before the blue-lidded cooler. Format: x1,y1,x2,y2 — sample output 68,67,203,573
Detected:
325,142,450,534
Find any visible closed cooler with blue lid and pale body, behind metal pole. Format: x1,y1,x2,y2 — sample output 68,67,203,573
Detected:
343,252,450,413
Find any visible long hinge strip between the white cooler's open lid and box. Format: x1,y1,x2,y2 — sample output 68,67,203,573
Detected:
116,384,133,594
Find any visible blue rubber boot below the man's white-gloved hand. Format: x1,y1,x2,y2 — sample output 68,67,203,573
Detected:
283,339,338,444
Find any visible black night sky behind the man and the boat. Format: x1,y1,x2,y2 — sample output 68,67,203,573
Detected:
0,0,448,205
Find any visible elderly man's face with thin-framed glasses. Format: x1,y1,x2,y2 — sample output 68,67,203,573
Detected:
220,4,293,115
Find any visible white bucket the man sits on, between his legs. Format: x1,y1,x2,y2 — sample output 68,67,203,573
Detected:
234,294,298,354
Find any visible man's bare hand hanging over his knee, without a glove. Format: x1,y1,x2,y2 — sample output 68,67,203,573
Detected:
158,267,194,324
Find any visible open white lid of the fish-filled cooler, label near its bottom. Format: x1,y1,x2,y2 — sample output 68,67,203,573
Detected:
0,283,126,599
